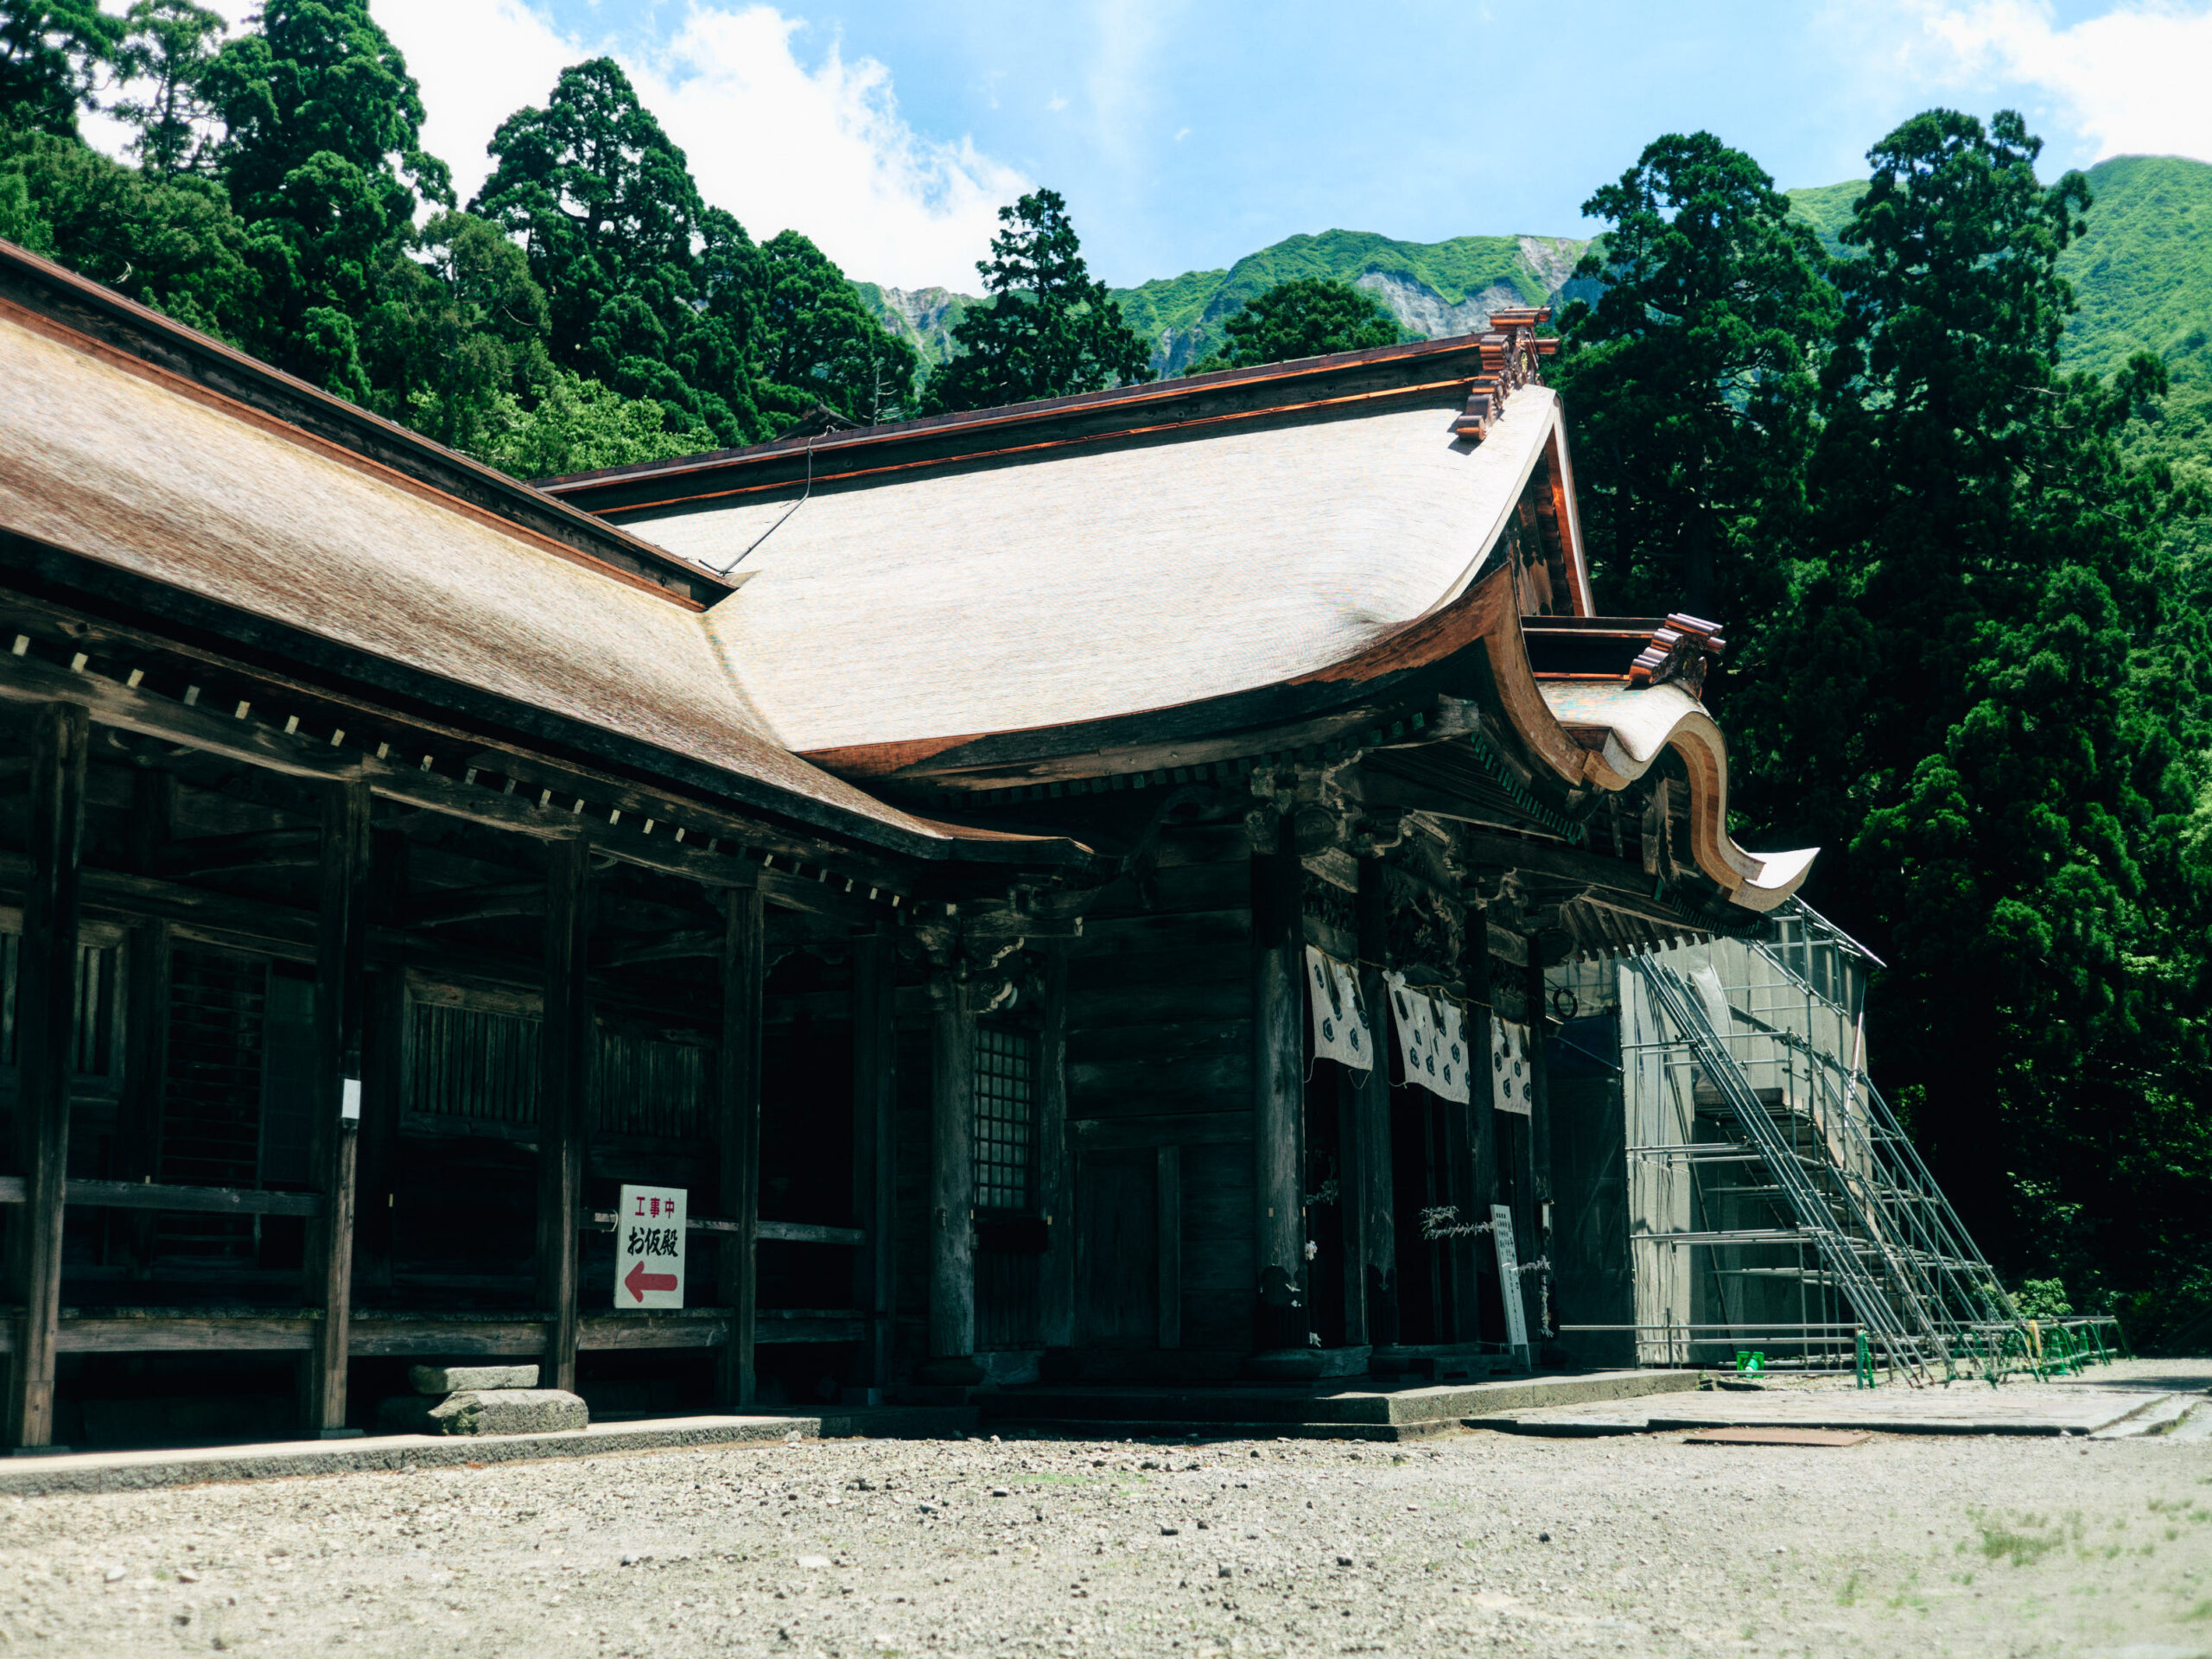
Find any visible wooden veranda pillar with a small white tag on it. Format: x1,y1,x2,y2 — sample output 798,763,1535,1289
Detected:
303,783,370,1433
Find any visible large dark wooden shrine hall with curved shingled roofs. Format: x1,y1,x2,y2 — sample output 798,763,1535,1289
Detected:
0,244,1809,1446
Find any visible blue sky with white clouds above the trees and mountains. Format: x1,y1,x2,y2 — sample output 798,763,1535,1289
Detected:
336,0,2212,288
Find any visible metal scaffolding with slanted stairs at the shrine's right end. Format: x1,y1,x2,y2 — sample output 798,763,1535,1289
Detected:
1621,905,2108,1382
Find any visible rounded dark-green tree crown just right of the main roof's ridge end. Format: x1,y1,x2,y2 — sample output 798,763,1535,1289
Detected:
1553,133,1836,623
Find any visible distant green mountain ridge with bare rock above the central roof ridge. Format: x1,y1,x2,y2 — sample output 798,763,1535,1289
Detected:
854,230,1586,374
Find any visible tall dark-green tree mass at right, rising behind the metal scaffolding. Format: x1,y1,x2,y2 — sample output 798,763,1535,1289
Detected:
1737,111,2212,1327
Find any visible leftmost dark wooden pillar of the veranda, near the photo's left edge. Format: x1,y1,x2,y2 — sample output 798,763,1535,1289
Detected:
7,703,91,1446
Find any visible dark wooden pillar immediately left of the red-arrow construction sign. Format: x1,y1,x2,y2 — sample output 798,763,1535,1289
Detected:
537,841,595,1389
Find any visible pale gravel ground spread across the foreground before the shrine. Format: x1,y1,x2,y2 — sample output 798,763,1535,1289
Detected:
0,1407,2212,1659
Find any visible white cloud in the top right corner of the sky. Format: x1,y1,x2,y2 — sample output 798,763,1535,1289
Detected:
1916,0,2212,162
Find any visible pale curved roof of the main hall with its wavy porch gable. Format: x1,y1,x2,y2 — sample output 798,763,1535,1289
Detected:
597,369,1812,909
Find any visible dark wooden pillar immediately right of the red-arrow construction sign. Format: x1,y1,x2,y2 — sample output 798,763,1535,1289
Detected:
715,889,774,1411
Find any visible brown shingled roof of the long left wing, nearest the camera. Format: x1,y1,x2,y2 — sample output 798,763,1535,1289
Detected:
0,245,1064,871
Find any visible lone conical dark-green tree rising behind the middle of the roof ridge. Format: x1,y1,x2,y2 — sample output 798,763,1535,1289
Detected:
923,190,1153,411
